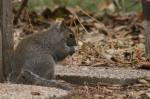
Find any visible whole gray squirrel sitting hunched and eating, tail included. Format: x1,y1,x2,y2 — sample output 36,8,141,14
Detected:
8,20,76,90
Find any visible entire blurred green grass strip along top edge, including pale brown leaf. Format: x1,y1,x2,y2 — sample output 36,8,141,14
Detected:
28,0,141,12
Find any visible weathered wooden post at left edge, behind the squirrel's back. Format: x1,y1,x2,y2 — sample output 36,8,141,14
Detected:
0,0,13,81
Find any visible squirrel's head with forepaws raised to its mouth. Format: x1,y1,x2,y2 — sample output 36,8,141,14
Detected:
49,20,77,61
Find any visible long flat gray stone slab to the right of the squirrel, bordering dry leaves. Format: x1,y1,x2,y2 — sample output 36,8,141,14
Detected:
56,65,150,85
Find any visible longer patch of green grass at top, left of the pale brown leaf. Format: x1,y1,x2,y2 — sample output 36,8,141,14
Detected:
28,0,101,11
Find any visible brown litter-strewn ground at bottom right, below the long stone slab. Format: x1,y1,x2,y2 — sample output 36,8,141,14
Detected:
68,83,150,99
